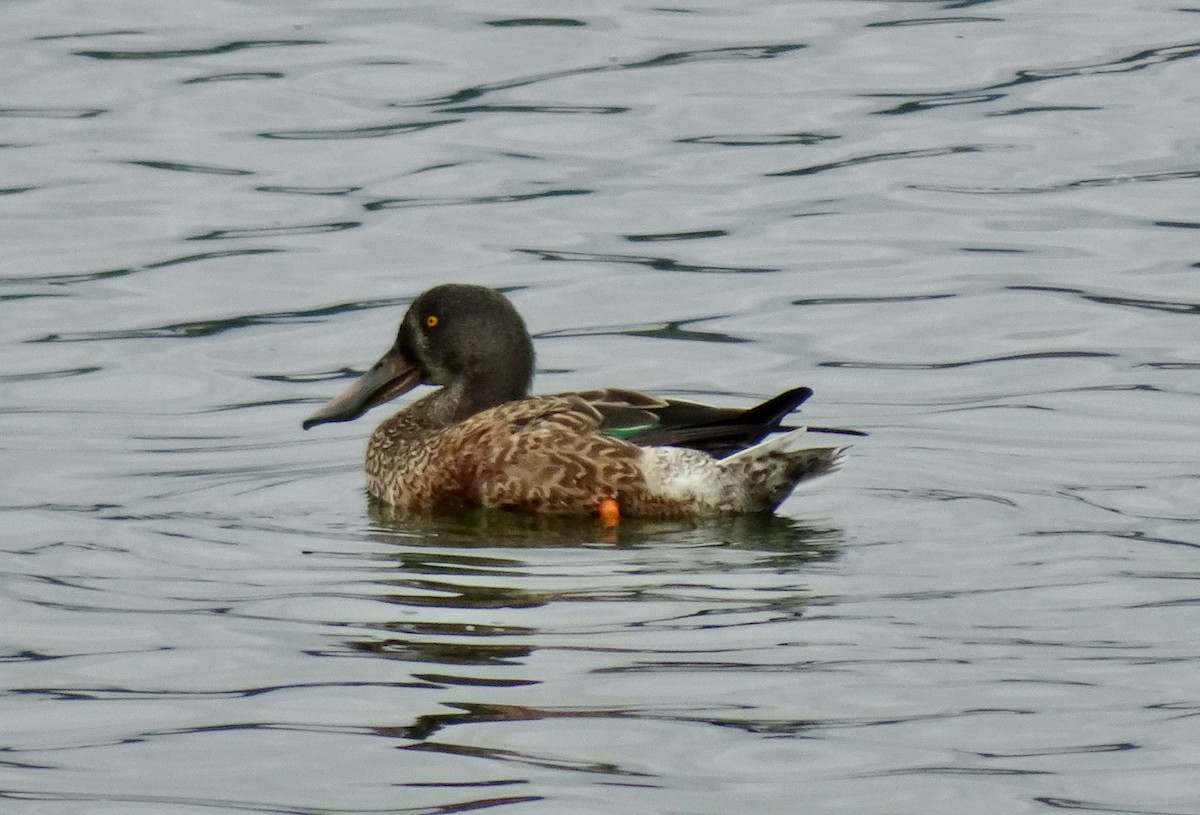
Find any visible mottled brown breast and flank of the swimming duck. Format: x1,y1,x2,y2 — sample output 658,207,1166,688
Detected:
366,396,662,516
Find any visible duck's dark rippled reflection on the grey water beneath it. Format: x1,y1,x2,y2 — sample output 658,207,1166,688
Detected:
314,502,844,775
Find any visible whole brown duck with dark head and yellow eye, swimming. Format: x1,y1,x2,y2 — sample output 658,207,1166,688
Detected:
302,283,865,518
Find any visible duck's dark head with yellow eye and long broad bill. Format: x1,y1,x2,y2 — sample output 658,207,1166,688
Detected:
304,283,534,430
